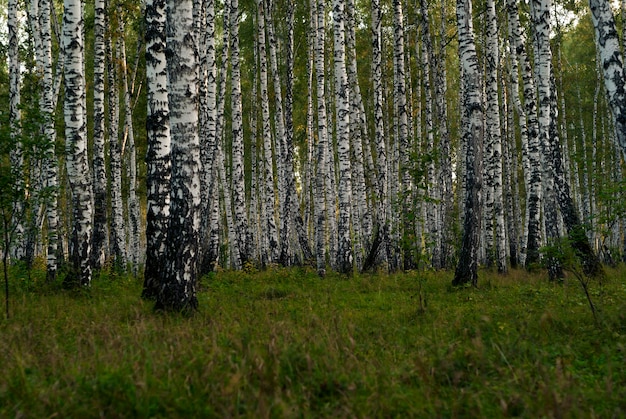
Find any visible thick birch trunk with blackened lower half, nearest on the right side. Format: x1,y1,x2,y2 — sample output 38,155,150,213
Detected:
452,0,484,286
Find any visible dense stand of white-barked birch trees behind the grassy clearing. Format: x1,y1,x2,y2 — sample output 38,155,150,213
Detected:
0,0,626,308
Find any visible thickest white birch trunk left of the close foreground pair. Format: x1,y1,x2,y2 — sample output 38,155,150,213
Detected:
63,0,93,286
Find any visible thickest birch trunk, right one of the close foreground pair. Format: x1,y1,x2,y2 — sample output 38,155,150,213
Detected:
155,0,201,311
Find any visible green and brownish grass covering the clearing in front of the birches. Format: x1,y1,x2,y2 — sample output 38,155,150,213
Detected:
0,268,626,418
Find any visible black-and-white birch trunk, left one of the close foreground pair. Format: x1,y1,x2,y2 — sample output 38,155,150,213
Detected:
142,0,171,299
